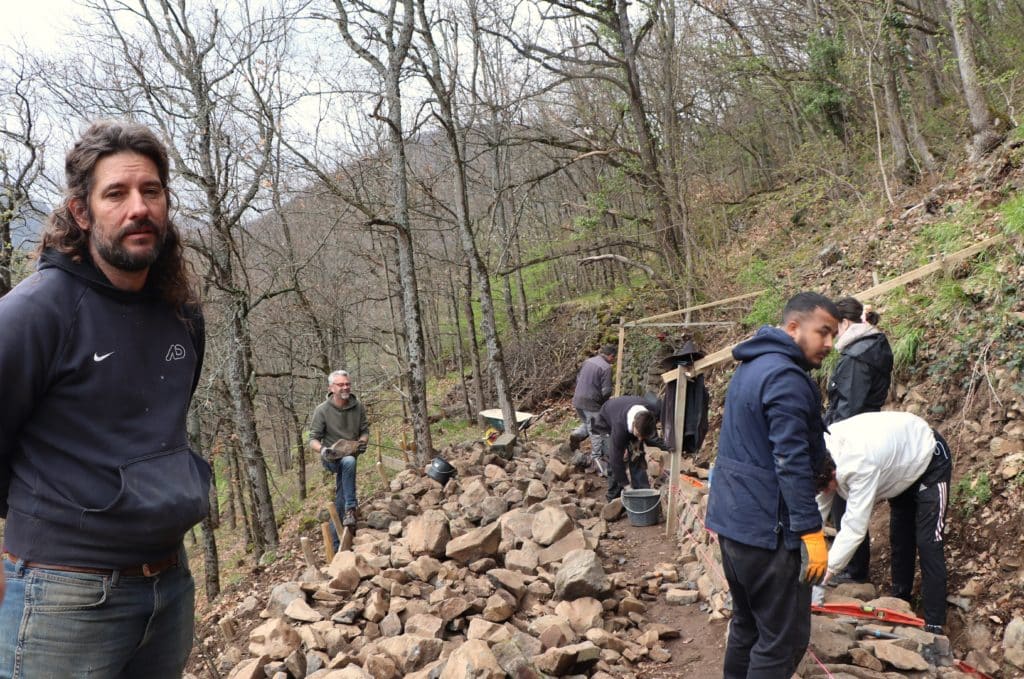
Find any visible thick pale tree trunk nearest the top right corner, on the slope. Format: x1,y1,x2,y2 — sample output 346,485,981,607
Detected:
945,0,1002,161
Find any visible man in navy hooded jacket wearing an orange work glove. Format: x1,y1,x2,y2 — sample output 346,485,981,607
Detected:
707,292,839,679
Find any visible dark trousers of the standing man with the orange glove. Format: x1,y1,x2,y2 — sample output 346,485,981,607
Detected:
719,536,811,679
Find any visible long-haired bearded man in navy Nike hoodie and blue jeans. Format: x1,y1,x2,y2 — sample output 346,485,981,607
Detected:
0,121,210,679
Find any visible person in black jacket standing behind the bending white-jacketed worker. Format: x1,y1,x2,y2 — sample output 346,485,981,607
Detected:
825,297,893,584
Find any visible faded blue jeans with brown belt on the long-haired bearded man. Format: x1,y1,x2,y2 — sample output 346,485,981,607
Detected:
0,549,196,679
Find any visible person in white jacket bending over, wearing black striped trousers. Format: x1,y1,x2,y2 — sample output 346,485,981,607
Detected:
817,412,952,634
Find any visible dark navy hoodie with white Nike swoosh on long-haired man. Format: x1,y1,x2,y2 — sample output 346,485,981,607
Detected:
0,251,210,568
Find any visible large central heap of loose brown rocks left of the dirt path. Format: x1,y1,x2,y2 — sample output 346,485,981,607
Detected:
216,443,696,679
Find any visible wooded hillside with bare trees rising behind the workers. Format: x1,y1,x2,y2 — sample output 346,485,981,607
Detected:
0,0,1024,659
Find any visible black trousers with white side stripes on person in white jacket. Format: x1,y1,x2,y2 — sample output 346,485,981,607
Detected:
889,431,952,625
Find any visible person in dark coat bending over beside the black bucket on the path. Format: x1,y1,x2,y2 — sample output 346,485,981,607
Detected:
591,396,665,502
